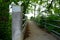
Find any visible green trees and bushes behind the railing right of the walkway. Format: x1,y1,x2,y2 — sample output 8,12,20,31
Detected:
31,0,60,35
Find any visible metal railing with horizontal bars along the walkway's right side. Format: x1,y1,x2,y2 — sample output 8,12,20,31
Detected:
42,20,60,39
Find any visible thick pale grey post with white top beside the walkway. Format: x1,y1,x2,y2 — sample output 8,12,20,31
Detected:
12,5,22,40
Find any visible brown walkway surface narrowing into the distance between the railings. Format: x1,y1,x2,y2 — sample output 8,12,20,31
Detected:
25,21,57,40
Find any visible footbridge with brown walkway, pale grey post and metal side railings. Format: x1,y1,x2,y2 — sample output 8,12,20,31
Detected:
12,2,60,40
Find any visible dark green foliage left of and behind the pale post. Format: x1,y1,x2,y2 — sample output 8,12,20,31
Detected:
0,0,29,40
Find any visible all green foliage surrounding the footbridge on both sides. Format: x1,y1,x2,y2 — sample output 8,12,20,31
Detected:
0,0,60,40
